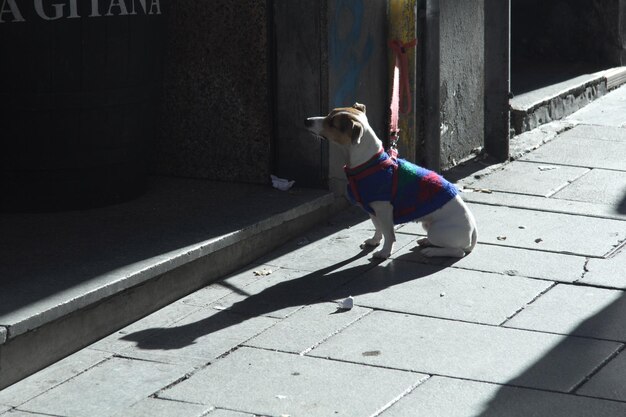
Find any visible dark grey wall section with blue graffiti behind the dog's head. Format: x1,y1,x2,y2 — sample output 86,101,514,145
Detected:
273,0,388,194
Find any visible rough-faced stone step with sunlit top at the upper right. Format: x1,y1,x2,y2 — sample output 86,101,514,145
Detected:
511,67,626,135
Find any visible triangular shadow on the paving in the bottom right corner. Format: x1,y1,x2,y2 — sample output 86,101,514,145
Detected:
476,294,626,417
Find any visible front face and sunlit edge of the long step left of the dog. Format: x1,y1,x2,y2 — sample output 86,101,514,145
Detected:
0,193,343,389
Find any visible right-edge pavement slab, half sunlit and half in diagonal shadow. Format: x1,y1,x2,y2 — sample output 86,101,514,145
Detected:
506,284,626,342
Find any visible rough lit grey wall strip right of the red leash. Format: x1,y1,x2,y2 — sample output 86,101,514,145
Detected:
440,0,484,169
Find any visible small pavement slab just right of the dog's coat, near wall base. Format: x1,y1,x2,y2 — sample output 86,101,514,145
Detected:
464,161,589,197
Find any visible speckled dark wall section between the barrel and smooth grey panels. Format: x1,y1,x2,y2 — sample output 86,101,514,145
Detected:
152,0,272,183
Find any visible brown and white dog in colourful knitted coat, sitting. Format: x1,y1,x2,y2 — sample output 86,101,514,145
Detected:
304,103,477,259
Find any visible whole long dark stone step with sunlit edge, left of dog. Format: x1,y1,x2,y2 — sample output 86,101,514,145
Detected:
0,178,342,389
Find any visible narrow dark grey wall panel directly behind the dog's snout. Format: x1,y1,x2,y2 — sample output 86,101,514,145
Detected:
272,0,328,188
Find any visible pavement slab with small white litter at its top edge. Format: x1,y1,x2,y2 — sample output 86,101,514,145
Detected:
246,303,372,353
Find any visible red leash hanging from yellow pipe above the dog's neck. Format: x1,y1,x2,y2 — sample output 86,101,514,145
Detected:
388,39,417,160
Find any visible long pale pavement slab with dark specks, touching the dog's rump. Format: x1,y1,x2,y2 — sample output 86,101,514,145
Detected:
470,204,626,257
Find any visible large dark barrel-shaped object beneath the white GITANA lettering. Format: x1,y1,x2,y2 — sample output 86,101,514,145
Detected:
0,2,165,211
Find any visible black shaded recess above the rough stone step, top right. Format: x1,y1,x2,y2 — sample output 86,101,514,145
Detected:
511,0,620,94
